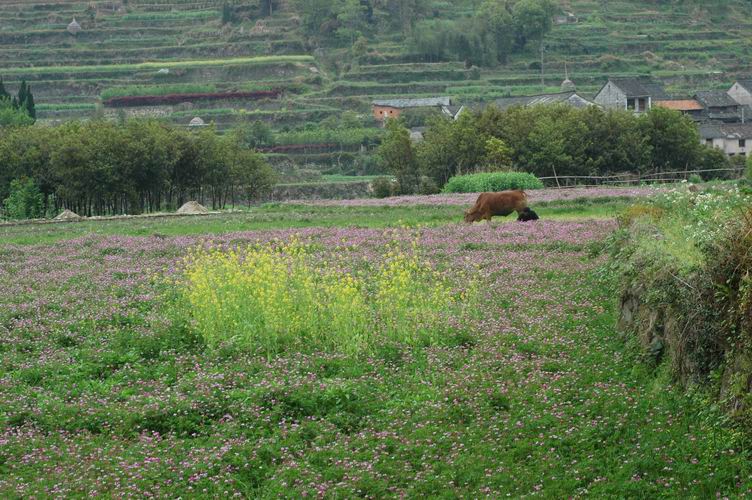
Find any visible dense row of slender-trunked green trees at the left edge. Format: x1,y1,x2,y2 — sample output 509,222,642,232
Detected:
0,120,275,216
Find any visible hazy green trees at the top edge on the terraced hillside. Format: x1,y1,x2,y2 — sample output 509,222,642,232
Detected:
295,0,558,66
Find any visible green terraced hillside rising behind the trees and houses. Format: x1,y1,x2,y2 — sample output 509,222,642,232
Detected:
0,0,752,172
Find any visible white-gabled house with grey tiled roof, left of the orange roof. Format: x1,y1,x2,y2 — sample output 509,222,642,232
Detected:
594,78,670,113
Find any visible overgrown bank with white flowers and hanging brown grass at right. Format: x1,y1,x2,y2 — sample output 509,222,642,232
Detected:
610,185,752,404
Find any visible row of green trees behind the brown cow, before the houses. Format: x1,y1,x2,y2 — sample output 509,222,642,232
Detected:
378,105,729,193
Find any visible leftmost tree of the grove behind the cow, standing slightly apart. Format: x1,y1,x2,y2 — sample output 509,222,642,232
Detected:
377,120,420,194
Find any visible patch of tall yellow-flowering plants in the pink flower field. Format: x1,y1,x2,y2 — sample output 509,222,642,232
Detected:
182,241,470,355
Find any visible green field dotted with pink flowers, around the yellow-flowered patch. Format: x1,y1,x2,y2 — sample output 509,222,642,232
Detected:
0,190,752,498
